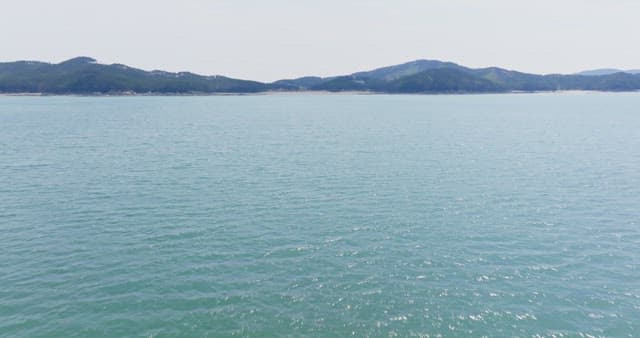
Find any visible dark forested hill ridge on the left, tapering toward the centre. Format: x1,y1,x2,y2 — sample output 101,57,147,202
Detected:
0,57,271,94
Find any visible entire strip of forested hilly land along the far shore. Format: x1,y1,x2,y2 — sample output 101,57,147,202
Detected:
0,57,640,95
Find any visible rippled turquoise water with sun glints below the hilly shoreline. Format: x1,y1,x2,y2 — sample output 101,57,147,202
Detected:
0,94,640,337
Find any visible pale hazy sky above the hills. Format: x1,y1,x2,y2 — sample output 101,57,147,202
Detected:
0,0,640,81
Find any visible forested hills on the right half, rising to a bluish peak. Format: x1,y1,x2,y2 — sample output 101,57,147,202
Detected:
306,60,640,93
